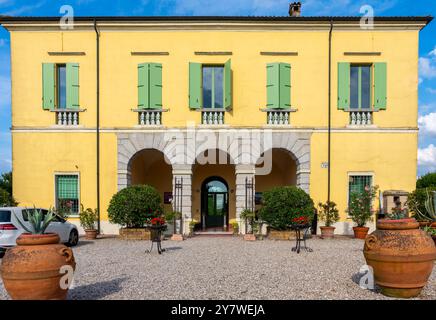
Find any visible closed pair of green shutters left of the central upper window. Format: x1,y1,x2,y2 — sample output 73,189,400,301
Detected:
138,62,162,109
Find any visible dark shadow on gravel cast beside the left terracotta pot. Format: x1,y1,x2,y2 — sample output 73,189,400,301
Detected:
68,277,128,300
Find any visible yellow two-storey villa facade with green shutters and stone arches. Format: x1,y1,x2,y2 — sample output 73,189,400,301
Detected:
0,13,431,234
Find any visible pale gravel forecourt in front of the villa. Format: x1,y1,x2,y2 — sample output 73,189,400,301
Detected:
0,237,436,300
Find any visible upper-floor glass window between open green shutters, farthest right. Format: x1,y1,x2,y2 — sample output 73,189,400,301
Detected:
350,65,372,110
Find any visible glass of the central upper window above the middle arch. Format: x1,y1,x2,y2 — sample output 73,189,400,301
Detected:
202,66,224,109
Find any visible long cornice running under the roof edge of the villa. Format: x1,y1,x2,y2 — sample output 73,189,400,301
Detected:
0,16,433,32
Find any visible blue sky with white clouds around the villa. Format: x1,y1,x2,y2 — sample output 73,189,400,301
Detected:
0,0,436,175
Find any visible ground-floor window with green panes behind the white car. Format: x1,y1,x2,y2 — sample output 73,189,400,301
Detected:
55,174,79,215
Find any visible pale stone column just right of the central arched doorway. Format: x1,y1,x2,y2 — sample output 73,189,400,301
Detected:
235,164,256,233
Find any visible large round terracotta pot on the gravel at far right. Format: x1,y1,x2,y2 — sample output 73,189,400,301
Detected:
363,218,436,298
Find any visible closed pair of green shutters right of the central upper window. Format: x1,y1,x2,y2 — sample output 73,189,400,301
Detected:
266,62,291,109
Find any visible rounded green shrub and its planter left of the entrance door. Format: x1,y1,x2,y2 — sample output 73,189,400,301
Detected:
108,185,163,240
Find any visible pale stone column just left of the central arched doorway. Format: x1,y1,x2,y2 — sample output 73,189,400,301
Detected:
173,164,192,234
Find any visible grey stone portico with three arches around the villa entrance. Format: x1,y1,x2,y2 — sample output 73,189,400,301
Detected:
117,130,311,233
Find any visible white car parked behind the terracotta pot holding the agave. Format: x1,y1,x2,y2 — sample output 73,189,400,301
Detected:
0,207,79,255
